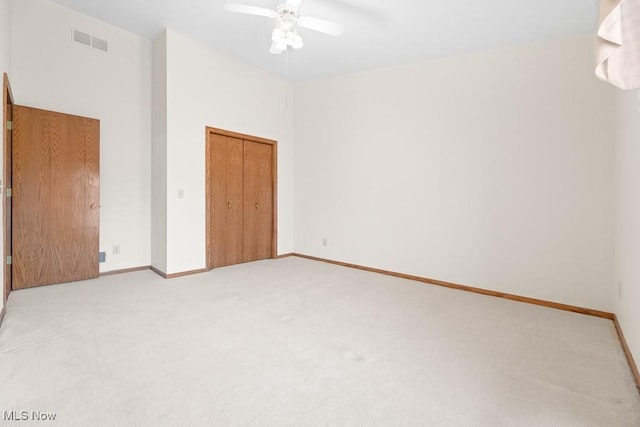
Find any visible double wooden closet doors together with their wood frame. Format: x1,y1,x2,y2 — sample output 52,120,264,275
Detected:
206,127,277,269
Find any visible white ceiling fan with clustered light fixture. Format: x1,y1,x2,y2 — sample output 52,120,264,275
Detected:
224,0,344,55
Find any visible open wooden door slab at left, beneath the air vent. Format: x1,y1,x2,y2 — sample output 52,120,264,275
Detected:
12,105,100,289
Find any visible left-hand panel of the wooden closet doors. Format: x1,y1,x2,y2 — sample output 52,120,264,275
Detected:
208,133,243,268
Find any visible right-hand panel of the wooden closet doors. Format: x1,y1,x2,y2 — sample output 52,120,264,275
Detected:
243,140,273,262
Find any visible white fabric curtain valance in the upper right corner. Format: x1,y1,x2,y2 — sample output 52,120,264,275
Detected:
596,0,640,89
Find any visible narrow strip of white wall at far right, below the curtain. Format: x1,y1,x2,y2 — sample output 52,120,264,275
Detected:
612,89,640,363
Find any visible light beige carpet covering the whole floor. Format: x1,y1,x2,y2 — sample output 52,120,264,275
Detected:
0,258,640,427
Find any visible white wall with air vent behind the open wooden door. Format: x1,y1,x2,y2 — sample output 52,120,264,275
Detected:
12,0,151,271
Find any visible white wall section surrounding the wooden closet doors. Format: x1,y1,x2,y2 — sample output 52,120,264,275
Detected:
159,31,293,274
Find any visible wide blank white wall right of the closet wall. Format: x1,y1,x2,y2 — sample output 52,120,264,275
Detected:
295,37,613,311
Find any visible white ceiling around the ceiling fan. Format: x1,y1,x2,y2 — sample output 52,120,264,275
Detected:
47,0,597,81
